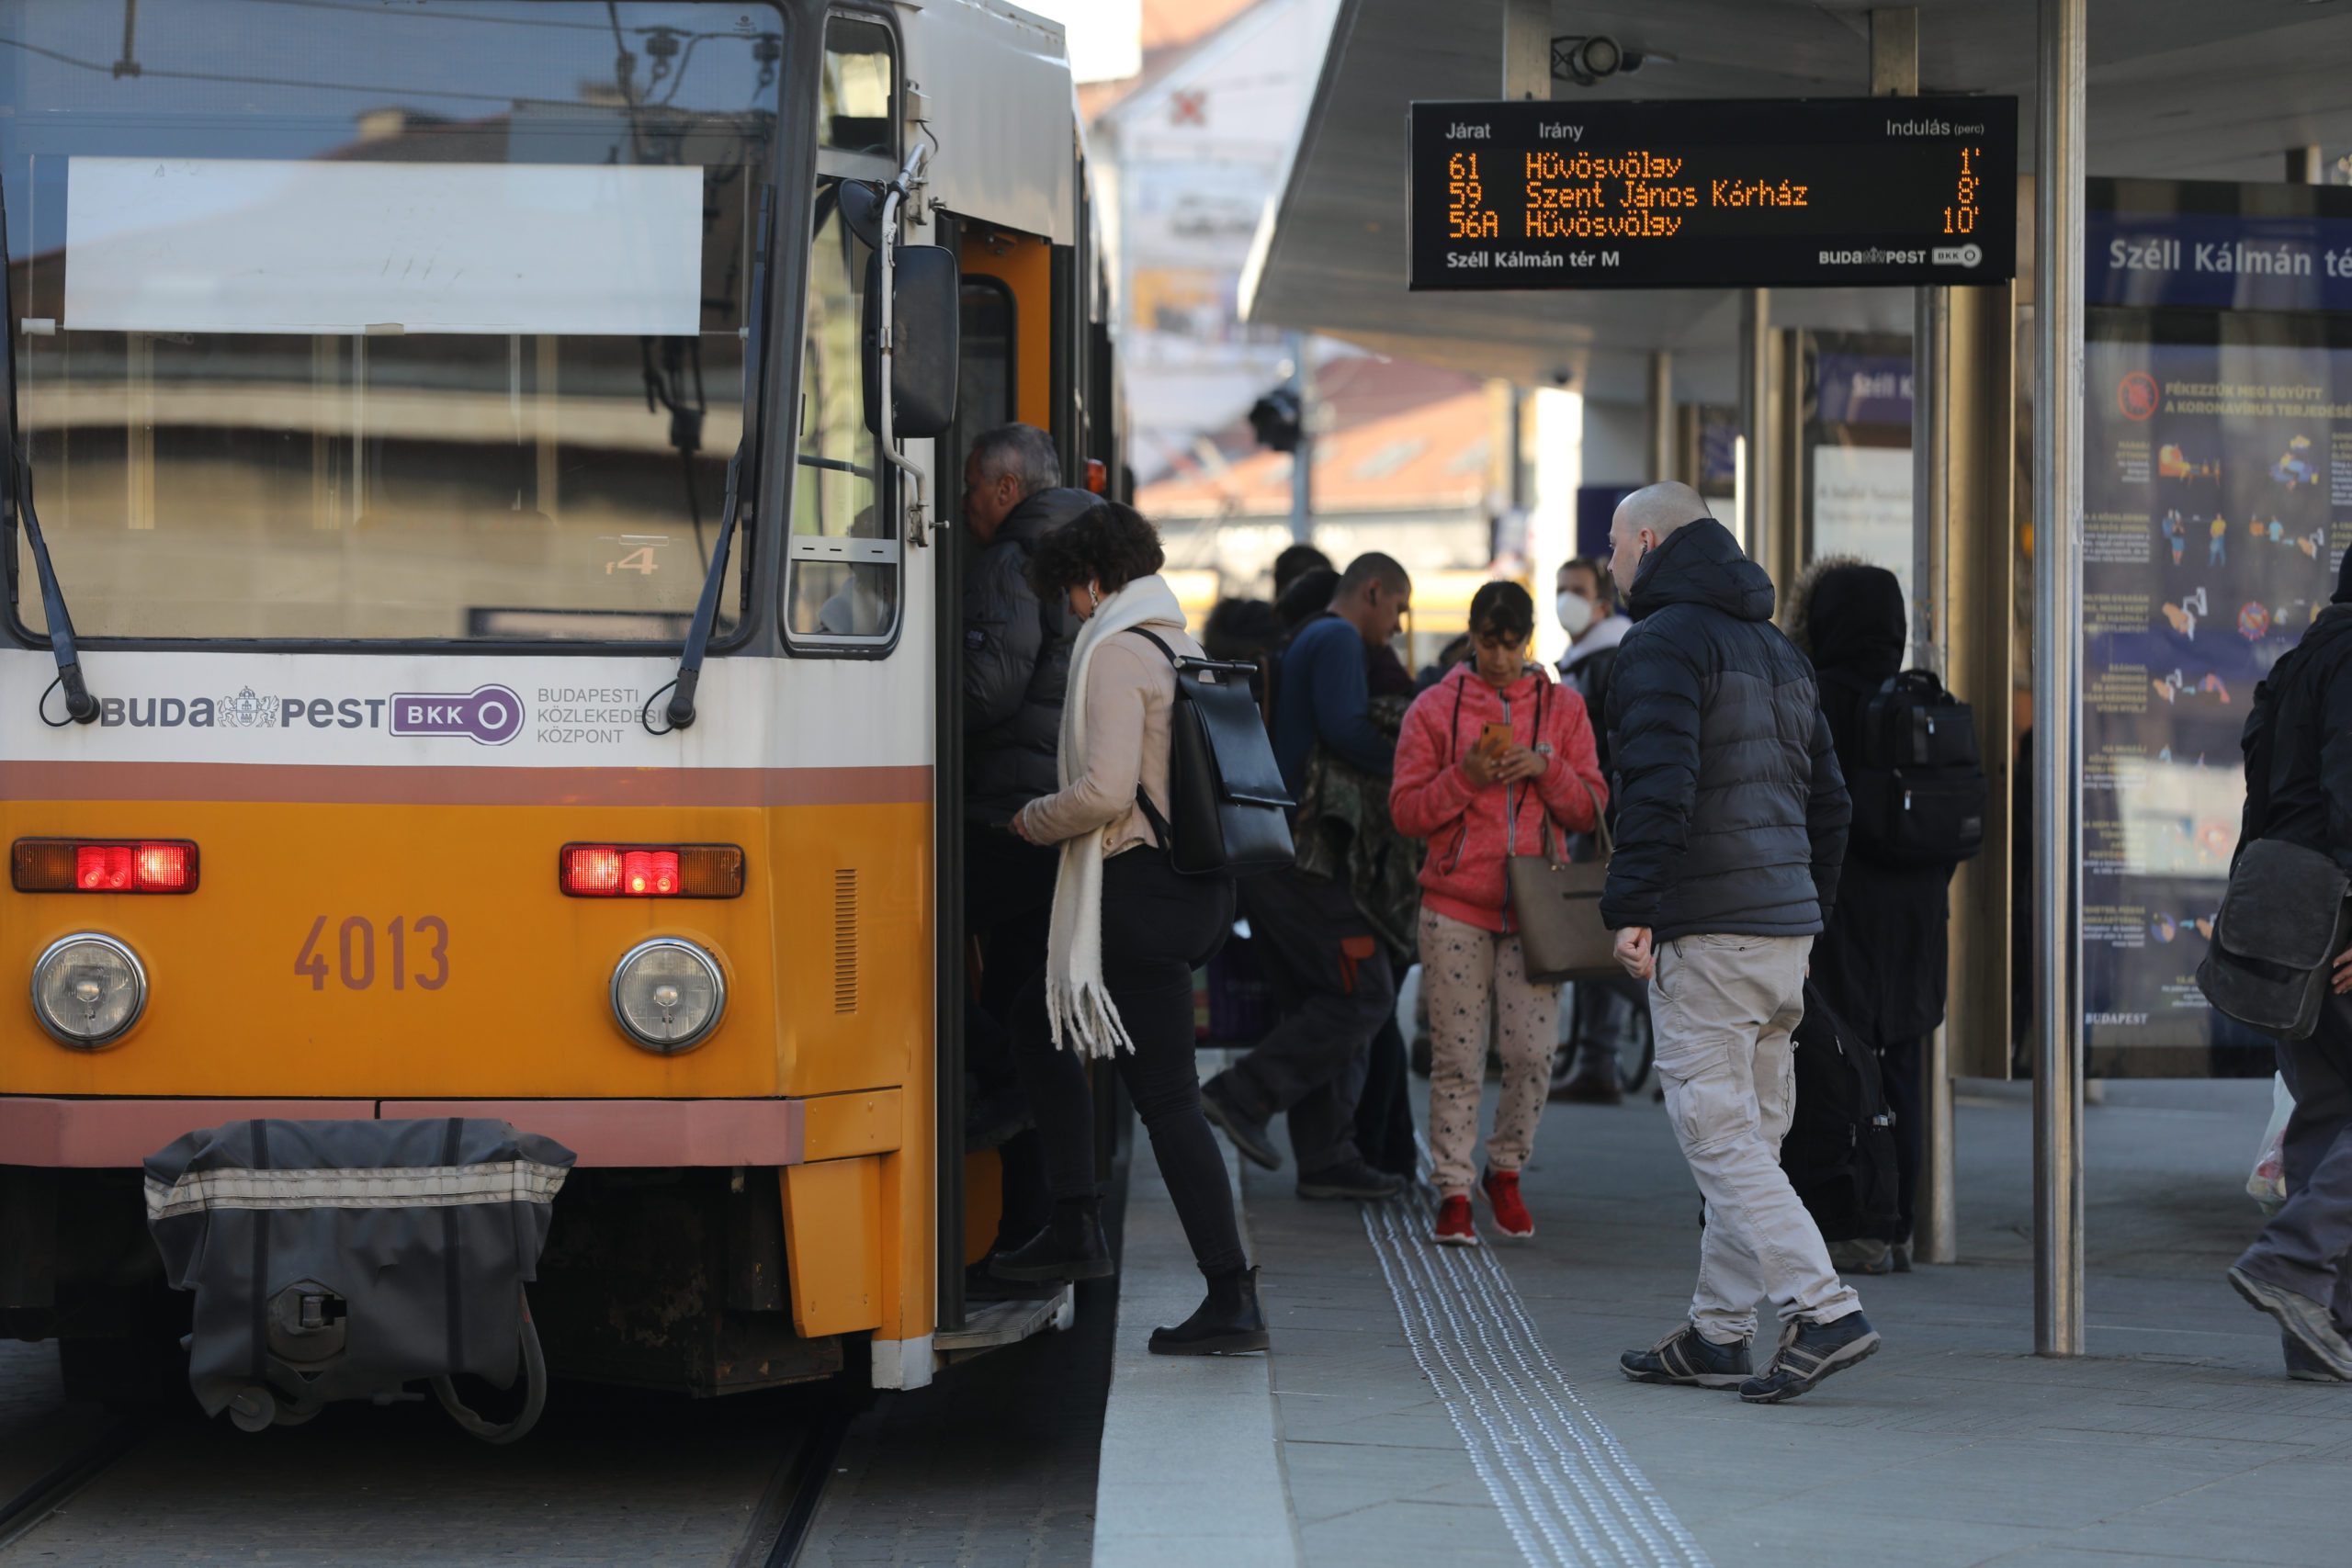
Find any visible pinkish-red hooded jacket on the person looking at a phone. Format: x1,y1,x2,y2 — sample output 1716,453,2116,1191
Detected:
1387,660,1609,931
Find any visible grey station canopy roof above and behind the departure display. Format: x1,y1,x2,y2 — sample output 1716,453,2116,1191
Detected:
1242,0,2352,402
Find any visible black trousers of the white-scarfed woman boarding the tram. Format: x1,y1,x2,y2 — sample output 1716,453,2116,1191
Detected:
1013,846,1249,1274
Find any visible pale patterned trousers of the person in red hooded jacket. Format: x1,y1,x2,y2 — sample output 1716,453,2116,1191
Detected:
1420,905,1559,1197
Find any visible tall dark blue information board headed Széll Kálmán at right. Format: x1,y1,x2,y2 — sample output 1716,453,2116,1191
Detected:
2082,181,2352,1075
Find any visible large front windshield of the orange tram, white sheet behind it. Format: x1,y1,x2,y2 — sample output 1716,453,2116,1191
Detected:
0,0,788,642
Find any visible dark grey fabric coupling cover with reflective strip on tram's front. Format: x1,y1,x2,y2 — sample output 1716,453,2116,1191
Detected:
146,1117,574,1441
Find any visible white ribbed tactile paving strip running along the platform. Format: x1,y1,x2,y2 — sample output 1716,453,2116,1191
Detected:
1364,1182,1710,1568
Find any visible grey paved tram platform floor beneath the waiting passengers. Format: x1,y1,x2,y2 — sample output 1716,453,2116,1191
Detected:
1093,1066,2352,1568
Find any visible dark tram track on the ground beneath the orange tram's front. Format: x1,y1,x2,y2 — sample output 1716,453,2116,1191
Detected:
0,1387,865,1568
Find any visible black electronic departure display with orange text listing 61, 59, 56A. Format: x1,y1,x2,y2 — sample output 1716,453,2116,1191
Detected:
1408,98,2018,289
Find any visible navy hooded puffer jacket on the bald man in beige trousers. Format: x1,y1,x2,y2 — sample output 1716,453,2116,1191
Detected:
1601,517,1853,942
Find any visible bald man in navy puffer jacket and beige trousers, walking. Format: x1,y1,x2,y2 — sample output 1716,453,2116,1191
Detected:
1601,482,1879,1404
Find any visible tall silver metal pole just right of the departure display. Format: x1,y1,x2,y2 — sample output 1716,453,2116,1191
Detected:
2034,0,2088,1357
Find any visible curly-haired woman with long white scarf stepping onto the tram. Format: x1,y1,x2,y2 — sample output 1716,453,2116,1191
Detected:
990,503,1265,1357
